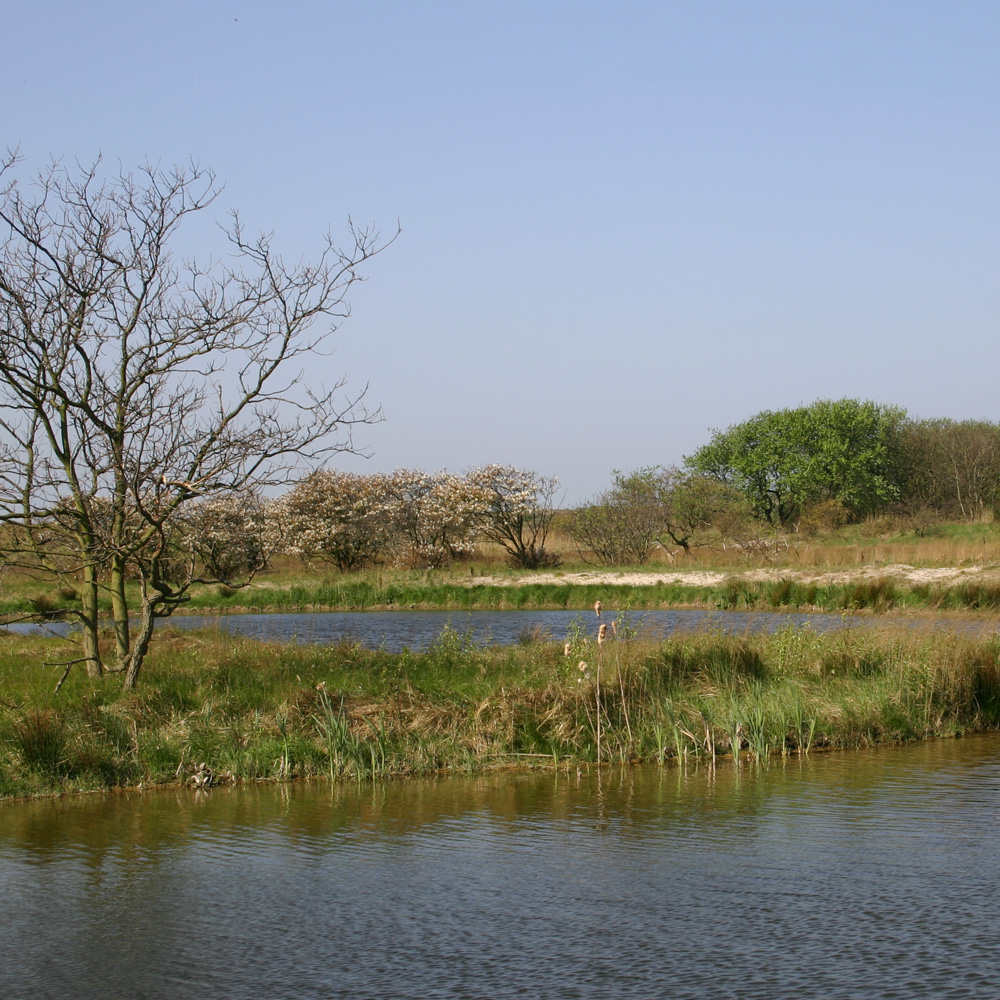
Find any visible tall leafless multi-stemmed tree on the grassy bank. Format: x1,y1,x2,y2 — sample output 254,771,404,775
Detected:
0,154,391,686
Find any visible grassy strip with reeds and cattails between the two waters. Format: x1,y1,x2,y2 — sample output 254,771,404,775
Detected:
0,628,1000,797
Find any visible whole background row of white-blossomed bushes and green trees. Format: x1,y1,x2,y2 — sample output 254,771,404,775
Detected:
60,399,1000,586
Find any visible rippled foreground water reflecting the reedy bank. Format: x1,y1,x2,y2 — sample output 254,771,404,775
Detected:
0,735,1000,1000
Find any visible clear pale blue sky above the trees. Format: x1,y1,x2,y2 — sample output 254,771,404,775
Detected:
0,0,1000,505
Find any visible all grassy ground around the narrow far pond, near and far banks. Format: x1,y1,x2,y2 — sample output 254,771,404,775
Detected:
0,522,1000,799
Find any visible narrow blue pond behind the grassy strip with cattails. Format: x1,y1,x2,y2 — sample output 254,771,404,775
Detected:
7,610,870,653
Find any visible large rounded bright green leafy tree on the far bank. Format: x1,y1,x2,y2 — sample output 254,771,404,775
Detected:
686,399,905,526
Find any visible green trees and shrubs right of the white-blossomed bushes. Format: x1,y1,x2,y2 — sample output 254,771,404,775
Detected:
569,399,1000,565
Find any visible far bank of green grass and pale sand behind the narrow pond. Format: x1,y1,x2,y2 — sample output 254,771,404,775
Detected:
0,563,1000,628
